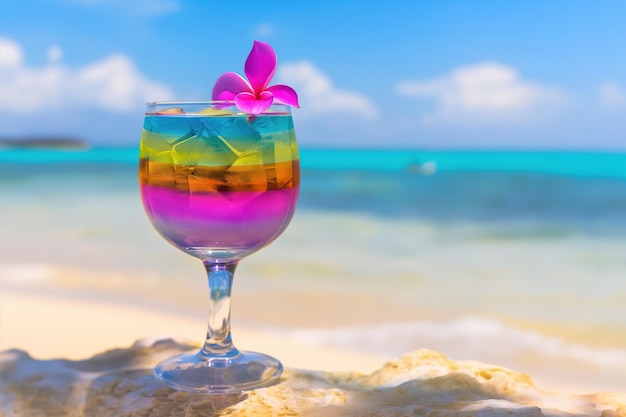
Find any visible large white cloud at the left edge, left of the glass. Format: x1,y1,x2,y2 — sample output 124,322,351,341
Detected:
0,39,172,113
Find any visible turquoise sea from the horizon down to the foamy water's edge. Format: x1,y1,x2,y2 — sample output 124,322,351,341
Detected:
0,148,626,392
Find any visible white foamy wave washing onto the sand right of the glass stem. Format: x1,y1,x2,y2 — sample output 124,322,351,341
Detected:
286,317,626,371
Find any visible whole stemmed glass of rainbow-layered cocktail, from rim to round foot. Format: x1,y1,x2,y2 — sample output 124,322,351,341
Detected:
139,101,300,394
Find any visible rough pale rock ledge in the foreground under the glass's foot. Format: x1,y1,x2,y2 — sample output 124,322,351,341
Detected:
0,340,626,417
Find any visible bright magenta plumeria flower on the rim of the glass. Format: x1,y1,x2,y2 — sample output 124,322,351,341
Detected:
213,41,300,114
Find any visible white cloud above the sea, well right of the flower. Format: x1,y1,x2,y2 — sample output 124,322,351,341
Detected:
396,62,561,123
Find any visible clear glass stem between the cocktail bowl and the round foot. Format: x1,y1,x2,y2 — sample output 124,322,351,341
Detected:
200,262,239,357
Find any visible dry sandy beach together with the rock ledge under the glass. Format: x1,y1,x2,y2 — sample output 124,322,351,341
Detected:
0,287,626,417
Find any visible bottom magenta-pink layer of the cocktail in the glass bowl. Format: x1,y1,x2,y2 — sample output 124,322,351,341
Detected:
141,184,299,258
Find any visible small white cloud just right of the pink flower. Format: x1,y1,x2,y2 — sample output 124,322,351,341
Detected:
277,61,378,119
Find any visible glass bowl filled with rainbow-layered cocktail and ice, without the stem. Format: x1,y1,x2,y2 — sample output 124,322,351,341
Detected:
140,103,300,261
